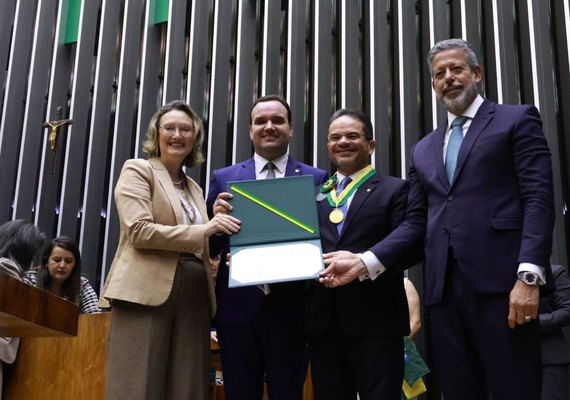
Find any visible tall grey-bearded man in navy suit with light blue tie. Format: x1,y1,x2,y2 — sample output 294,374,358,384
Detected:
322,39,554,400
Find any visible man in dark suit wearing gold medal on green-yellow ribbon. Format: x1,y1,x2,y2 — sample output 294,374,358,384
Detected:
305,109,410,400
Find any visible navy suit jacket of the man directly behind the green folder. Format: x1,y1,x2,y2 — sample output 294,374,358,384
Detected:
206,157,328,326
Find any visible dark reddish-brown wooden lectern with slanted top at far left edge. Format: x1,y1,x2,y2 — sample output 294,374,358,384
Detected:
0,272,79,337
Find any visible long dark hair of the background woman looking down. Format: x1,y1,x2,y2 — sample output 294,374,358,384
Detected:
38,236,81,304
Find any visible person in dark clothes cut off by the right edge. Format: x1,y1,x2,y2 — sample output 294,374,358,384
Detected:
538,265,570,400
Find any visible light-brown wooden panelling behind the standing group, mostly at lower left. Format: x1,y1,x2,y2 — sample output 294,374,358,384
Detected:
3,312,313,400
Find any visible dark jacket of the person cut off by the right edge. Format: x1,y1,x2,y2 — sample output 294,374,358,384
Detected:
538,265,570,365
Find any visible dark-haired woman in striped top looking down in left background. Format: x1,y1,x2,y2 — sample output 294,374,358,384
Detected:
24,236,101,314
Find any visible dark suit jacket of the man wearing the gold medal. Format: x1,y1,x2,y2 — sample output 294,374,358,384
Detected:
305,170,410,338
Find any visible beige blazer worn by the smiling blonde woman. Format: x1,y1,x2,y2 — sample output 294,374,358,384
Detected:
99,158,216,316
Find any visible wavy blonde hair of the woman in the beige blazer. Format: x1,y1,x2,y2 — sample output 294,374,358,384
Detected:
143,100,205,167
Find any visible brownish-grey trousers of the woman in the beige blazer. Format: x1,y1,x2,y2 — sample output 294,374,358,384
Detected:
105,260,210,400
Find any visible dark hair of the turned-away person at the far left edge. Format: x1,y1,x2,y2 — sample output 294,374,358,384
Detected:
0,219,45,271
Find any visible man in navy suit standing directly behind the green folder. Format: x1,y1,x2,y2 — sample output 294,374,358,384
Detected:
207,95,328,400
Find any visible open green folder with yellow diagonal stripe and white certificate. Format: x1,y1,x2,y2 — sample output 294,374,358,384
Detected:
227,175,324,287
